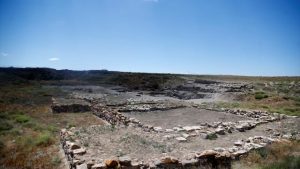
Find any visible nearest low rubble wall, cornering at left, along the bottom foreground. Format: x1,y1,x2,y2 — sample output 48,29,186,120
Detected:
60,128,290,169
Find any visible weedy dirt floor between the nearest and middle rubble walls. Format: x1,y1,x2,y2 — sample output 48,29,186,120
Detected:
69,117,300,162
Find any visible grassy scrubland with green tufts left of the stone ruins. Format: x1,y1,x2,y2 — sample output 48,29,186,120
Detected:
0,76,101,169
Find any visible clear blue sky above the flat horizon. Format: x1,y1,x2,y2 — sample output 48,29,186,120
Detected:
0,0,300,76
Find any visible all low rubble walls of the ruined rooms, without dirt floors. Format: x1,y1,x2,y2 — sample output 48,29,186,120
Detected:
52,97,299,169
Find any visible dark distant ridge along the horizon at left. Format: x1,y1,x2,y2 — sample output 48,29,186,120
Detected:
0,67,180,90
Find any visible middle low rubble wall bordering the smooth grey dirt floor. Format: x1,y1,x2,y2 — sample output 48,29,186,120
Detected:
92,104,286,141
